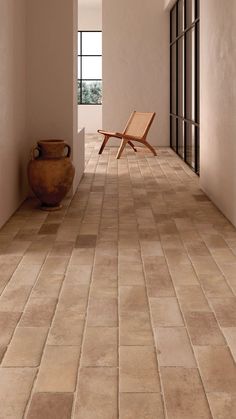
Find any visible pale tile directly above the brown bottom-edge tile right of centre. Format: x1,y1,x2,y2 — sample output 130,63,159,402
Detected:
155,327,196,368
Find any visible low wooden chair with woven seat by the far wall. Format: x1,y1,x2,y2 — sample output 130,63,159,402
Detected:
98,111,157,159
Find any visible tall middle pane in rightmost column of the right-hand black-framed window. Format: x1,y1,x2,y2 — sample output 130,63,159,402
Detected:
186,28,196,121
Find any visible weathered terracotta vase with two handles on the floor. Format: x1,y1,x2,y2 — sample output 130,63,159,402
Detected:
28,140,75,211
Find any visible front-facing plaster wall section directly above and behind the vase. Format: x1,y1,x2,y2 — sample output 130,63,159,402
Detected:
27,0,84,194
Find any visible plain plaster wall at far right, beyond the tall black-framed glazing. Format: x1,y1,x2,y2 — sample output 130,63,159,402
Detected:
200,0,236,225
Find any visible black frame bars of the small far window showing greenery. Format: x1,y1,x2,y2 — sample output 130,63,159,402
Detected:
77,30,102,106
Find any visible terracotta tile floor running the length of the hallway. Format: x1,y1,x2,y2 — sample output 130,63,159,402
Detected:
0,136,236,419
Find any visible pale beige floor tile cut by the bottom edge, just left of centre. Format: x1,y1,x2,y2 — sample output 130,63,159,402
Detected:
74,367,118,419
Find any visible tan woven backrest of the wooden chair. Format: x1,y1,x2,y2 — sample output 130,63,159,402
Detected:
123,111,156,139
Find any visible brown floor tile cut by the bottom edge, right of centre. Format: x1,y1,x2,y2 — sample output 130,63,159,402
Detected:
161,367,212,419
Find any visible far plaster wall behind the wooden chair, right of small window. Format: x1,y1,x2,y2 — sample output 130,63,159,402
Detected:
103,0,169,146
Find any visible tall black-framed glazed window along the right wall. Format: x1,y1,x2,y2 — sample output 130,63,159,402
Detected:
170,0,200,174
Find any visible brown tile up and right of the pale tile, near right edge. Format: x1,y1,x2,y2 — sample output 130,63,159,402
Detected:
184,311,226,346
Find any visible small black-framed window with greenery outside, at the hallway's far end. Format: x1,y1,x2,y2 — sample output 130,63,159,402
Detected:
78,31,102,105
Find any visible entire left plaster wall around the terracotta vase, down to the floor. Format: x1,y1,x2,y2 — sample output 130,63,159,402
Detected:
0,0,84,230
